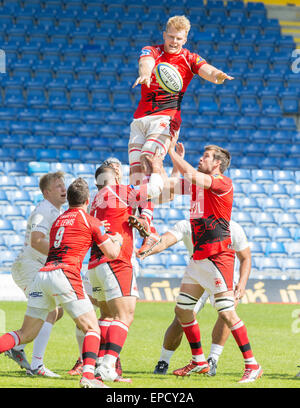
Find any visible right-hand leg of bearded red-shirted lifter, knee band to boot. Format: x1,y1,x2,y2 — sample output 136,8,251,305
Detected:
215,291,263,383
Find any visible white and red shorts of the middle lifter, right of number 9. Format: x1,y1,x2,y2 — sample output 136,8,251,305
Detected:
89,262,139,302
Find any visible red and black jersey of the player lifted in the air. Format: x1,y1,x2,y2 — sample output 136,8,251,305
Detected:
134,44,206,130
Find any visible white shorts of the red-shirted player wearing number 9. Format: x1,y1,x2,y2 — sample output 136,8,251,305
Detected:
26,269,94,320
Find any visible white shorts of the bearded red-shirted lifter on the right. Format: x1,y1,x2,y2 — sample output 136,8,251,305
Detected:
182,258,232,295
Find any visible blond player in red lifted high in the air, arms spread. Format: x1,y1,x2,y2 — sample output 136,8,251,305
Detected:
128,16,233,255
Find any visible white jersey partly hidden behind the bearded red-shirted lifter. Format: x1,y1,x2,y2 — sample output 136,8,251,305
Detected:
168,220,249,280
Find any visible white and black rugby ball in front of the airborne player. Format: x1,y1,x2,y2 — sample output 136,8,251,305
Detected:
155,62,183,93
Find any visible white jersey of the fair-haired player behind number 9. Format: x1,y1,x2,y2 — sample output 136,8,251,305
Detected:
18,200,62,265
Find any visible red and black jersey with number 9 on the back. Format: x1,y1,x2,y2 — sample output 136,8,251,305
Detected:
41,208,109,279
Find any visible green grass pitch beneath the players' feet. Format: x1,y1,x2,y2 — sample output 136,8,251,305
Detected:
0,302,300,392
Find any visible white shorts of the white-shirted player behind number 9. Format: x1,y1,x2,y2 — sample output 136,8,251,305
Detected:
11,258,44,299
